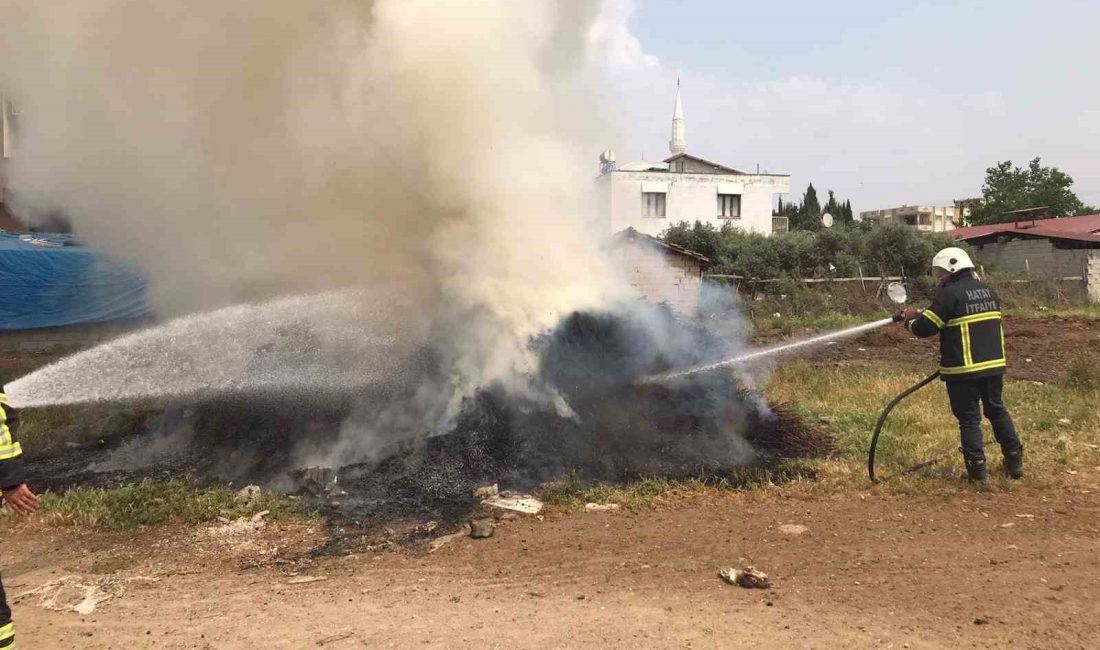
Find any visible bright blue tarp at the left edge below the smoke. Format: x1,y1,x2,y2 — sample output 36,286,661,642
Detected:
0,232,149,330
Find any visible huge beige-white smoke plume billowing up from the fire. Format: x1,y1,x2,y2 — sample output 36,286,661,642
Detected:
0,0,642,453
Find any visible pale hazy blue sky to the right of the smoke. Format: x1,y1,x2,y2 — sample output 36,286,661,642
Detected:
590,0,1100,212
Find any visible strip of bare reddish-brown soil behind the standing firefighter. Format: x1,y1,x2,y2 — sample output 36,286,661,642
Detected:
814,317,1100,382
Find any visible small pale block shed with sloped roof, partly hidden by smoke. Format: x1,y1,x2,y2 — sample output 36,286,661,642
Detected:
612,228,711,316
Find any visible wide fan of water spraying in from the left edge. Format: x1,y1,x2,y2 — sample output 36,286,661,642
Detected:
7,289,427,407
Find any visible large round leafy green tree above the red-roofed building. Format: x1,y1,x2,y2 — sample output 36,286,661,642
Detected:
970,158,1090,224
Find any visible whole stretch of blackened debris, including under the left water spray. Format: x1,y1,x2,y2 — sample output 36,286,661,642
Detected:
27,306,831,541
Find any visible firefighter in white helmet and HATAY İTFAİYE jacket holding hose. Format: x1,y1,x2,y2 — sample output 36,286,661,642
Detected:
900,247,1024,483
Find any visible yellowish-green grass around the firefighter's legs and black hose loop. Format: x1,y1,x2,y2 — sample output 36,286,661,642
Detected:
765,360,1100,492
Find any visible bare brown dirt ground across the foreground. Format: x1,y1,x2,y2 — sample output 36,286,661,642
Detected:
0,477,1100,649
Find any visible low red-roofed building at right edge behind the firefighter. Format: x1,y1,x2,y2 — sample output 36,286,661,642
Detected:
948,214,1100,302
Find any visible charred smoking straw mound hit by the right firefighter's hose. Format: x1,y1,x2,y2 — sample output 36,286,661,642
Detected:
325,309,832,527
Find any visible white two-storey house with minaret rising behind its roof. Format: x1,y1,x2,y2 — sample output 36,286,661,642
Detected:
596,87,791,235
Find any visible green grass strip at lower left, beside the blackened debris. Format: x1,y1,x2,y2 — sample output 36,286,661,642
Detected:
33,477,309,530
